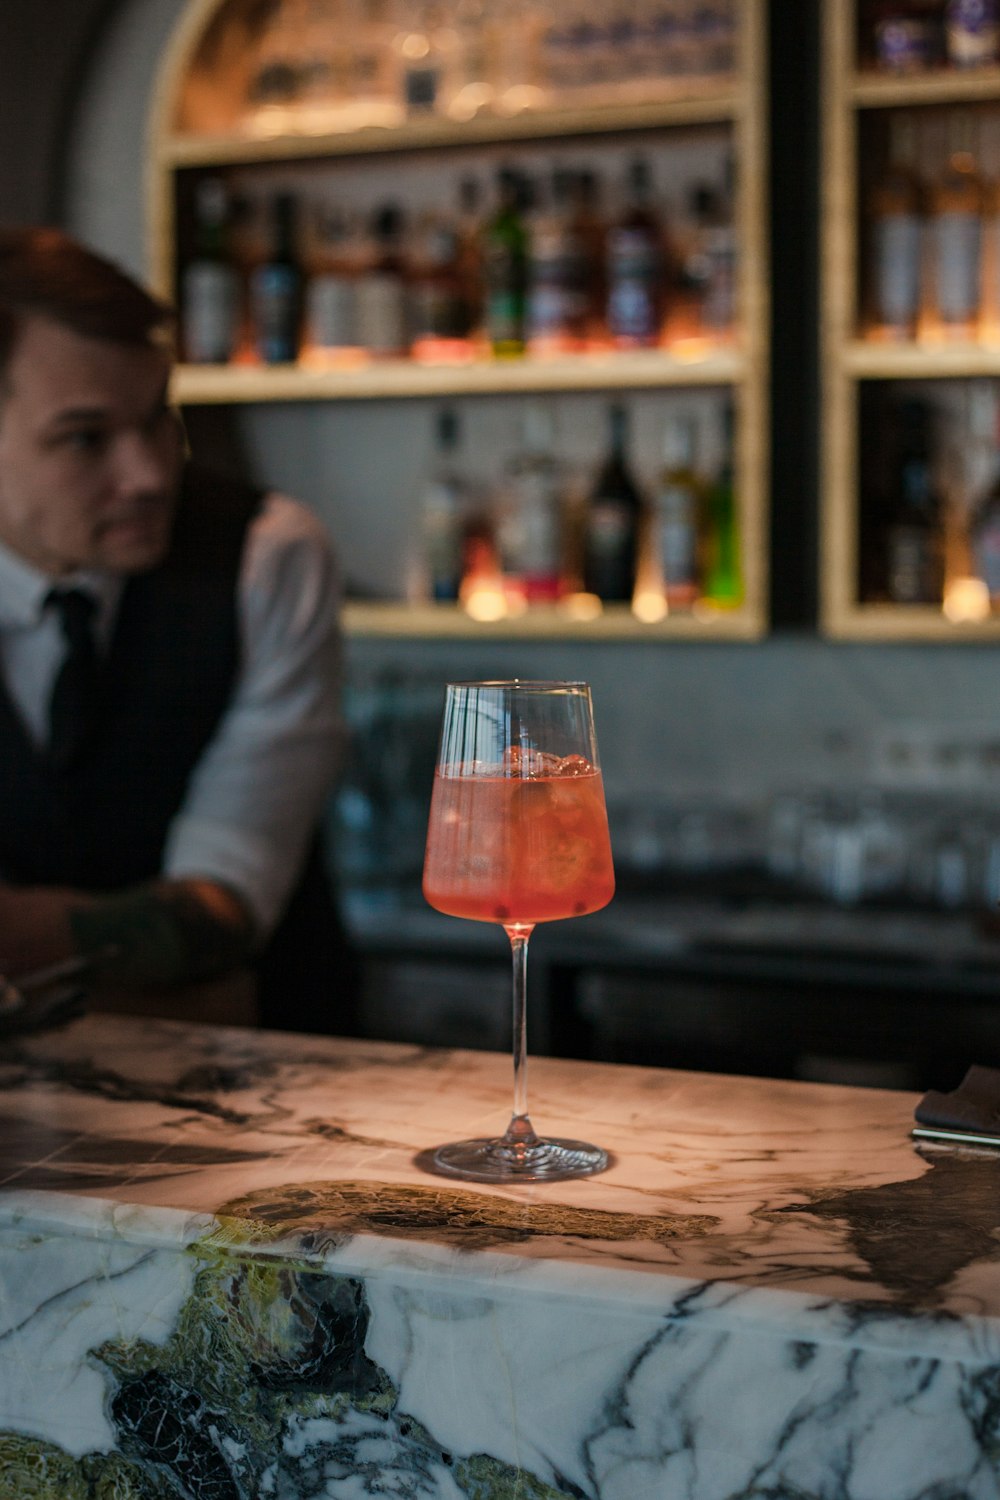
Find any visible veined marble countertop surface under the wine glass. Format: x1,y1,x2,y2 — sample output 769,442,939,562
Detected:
0,1016,1000,1359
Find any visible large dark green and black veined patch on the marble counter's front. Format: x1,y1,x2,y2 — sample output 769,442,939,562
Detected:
0,1212,593,1500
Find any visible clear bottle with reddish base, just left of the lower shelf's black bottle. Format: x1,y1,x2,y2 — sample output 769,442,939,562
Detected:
496,404,565,605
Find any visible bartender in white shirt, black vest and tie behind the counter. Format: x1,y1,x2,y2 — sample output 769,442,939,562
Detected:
0,228,354,1031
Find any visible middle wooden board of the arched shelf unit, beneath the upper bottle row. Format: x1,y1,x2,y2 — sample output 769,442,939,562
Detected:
172,345,745,407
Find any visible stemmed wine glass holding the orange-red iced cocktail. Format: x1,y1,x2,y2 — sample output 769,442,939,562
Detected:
423,681,615,1182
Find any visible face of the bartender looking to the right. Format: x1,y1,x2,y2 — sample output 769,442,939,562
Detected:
0,318,183,578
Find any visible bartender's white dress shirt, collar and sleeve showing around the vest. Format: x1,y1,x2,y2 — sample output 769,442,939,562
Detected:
0,495,343,936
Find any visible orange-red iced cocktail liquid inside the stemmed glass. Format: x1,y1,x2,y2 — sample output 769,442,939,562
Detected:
423,756,615,927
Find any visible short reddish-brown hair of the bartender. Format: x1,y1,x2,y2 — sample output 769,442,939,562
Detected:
0,227,175,380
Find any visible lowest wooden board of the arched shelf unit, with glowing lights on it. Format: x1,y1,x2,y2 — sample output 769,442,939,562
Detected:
343,603,765,642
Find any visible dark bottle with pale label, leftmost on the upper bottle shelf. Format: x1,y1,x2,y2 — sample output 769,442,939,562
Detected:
180,177,240,365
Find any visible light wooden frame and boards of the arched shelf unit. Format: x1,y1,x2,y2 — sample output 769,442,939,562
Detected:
147,0,769,642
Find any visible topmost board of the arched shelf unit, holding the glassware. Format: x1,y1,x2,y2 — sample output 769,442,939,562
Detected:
157,80,741,168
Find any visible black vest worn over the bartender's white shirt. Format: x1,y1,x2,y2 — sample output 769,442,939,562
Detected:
0,468,354,1031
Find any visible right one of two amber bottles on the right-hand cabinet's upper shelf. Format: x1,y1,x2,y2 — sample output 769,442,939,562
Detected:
930,110,982,338
